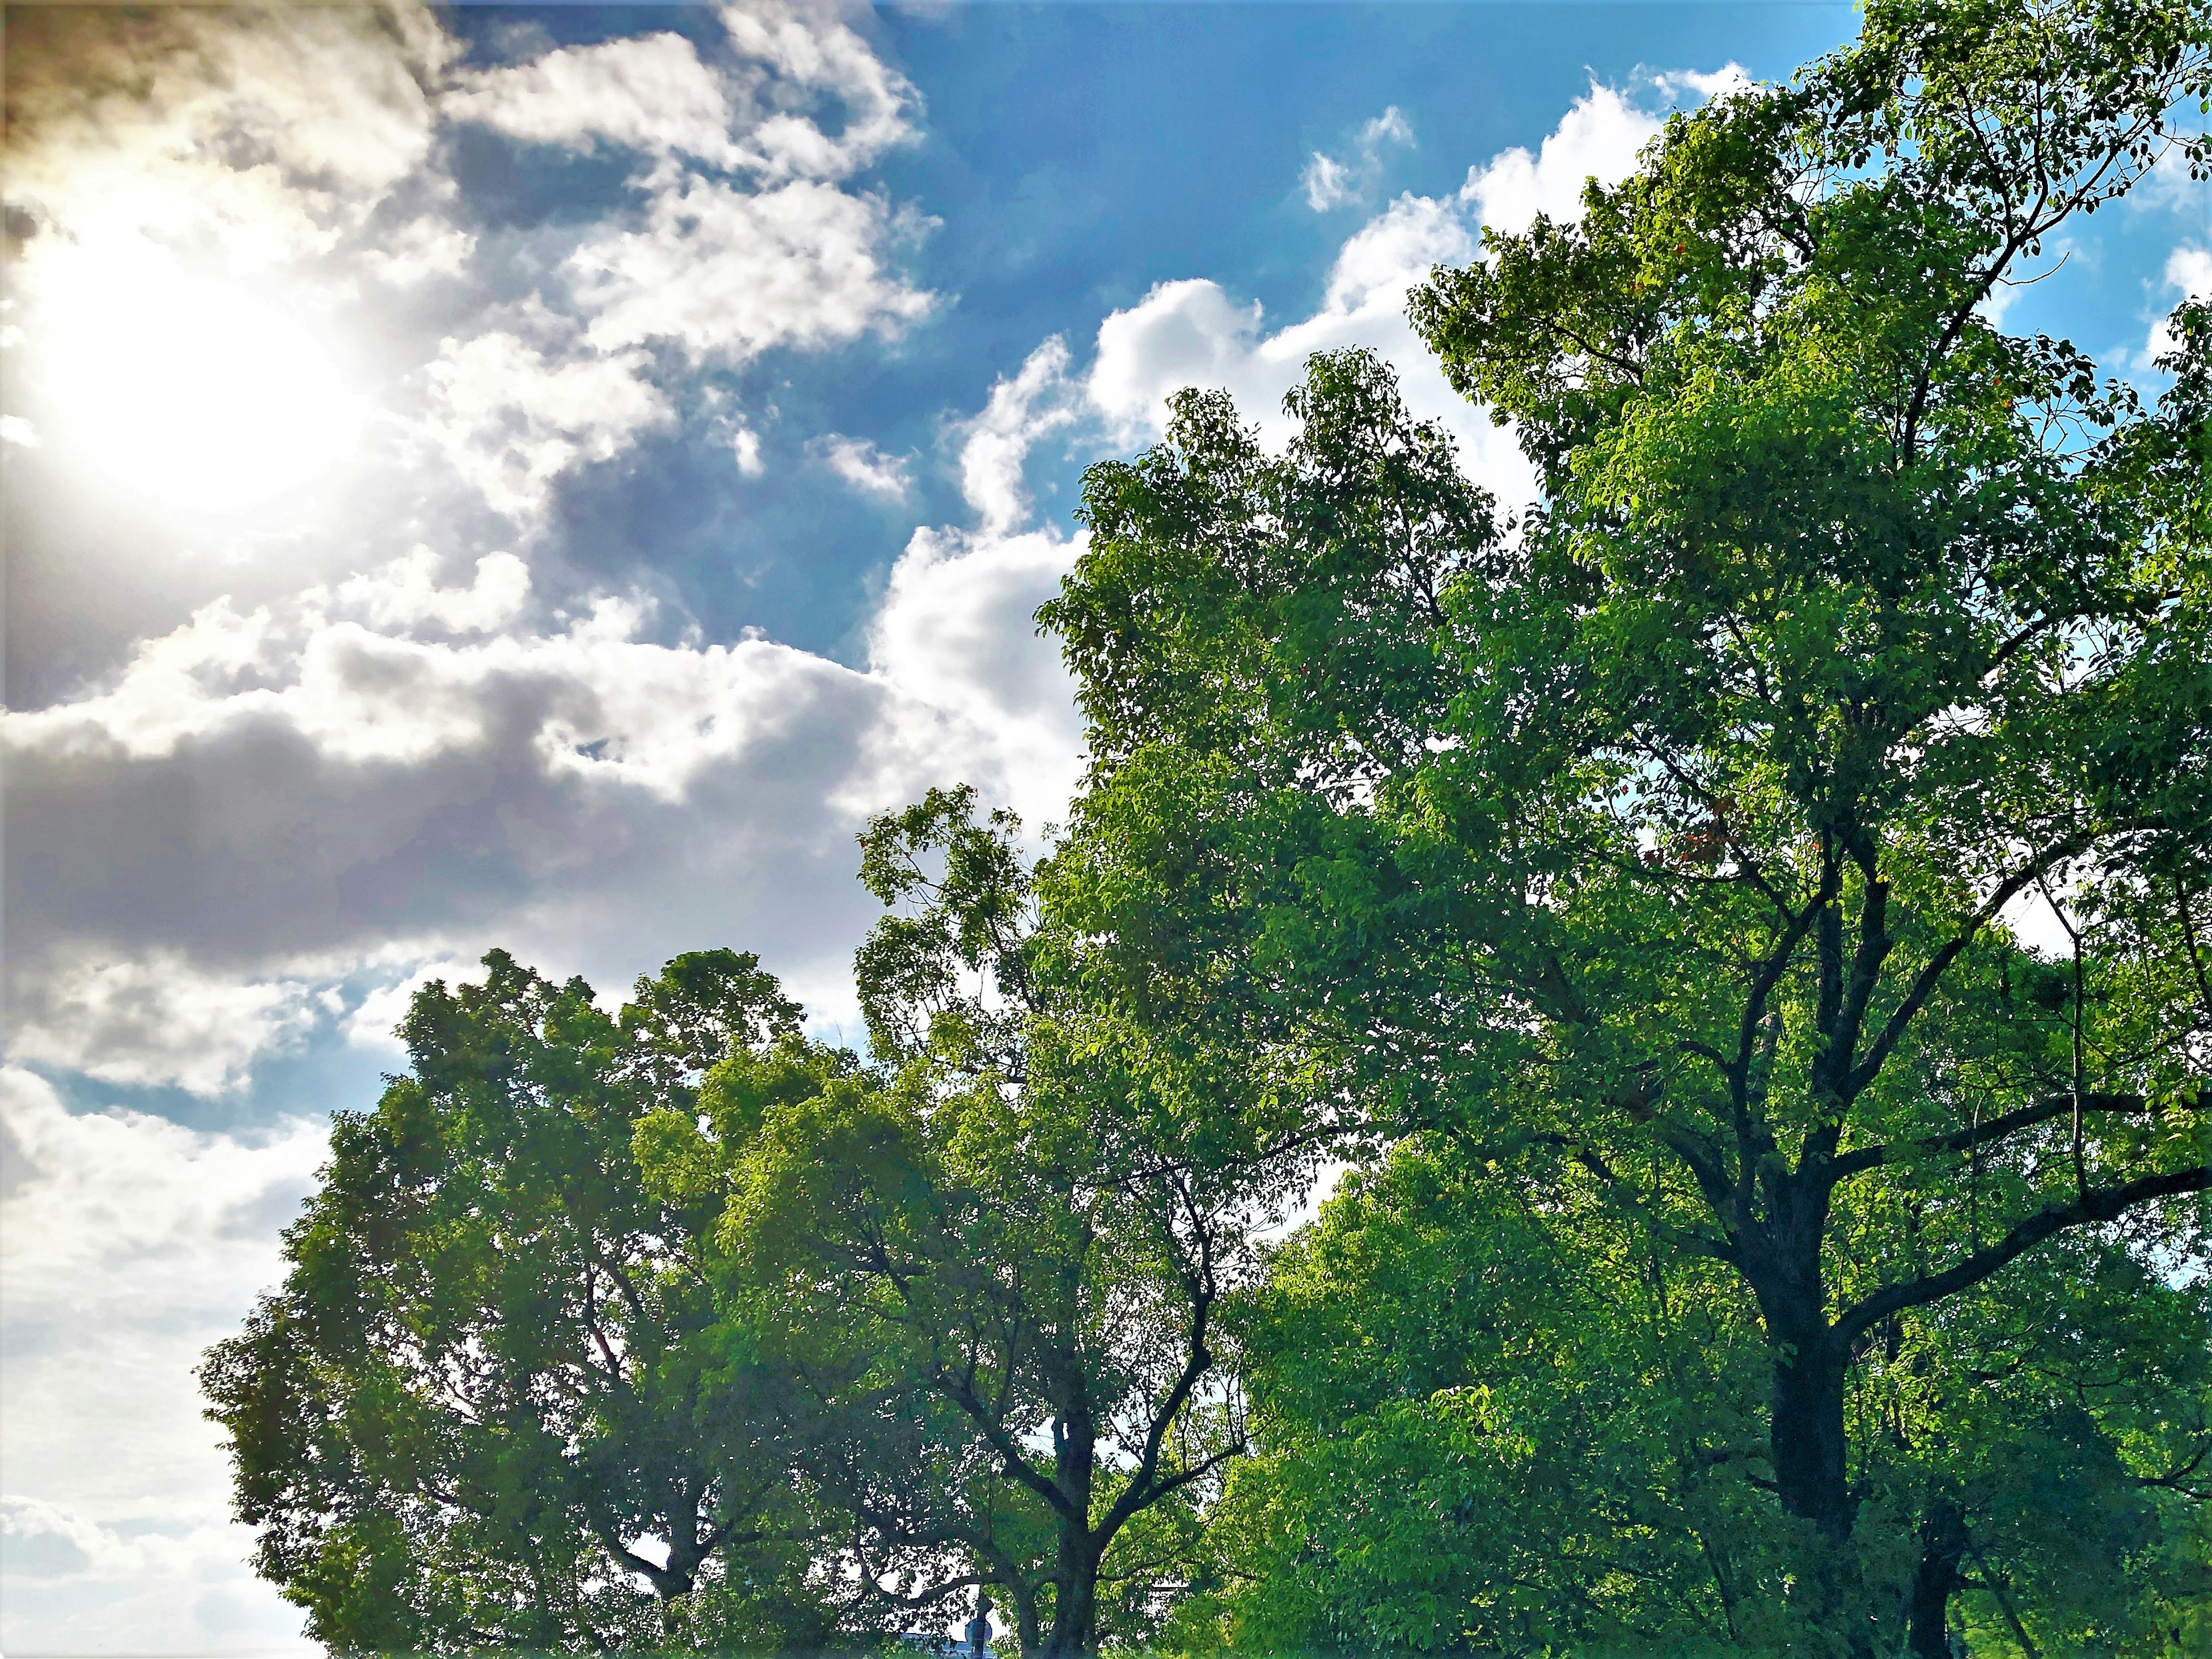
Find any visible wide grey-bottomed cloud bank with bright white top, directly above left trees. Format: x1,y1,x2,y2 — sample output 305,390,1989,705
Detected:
0,506,1075,1093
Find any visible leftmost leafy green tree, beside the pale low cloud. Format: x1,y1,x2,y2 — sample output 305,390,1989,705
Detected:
201,951,836,1652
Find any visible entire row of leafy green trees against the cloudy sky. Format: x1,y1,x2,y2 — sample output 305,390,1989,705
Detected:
206,0,2212,1657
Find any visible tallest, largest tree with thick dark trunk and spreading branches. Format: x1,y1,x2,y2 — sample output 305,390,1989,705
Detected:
1042,0,2212,1650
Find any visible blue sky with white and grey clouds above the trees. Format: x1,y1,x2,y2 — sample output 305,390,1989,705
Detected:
0,0,2212,1657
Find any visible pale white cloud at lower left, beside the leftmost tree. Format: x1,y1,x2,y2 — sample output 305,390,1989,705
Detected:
0,1066,327,1654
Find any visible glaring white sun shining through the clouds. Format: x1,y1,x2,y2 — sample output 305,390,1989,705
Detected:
24,250,361,513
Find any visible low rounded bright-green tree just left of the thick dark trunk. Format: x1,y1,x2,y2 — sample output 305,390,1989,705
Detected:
1185,1132,1783,1652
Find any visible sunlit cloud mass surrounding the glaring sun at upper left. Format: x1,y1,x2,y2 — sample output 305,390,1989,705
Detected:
9,0,931,539
